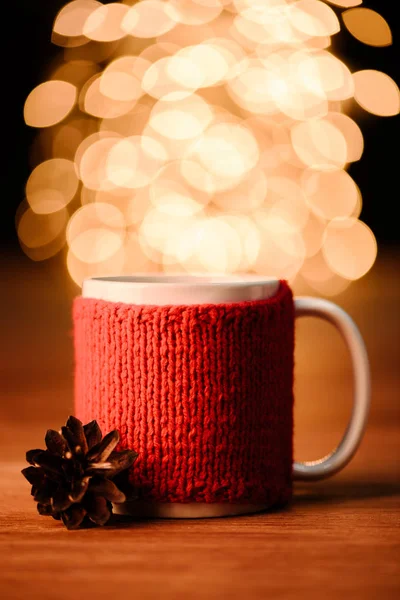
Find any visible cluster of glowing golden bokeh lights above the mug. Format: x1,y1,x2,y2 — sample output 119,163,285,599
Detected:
17,0,400,295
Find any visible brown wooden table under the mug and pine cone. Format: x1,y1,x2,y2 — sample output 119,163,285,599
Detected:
0,252,400,600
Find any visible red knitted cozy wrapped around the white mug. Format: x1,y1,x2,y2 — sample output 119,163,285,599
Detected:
73,282,294,506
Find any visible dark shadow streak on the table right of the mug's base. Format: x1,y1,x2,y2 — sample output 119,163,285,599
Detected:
293,480,400,506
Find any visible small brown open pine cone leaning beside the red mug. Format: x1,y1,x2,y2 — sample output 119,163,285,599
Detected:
22,416,137,529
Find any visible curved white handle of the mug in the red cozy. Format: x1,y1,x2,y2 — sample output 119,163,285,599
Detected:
293,297,371,481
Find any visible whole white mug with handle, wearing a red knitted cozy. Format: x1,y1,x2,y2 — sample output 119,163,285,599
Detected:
73,275,370,517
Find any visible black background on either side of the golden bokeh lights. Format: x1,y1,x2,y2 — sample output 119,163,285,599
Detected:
0,0,400,250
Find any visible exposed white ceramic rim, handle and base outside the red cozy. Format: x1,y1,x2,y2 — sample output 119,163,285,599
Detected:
78,274,370,517
